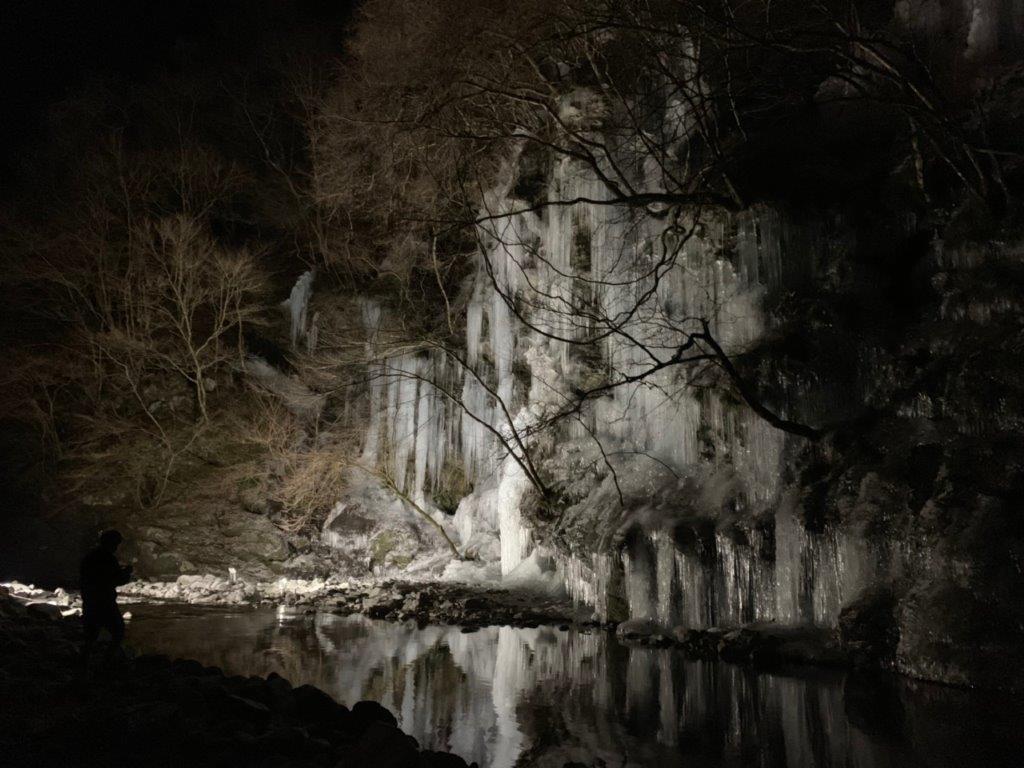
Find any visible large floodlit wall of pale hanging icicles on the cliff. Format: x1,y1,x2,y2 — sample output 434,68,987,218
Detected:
354,151,868,627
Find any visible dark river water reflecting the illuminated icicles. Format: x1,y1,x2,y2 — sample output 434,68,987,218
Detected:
129,606,1024,768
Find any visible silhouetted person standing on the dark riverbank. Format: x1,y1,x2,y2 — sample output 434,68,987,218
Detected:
80,530,131,665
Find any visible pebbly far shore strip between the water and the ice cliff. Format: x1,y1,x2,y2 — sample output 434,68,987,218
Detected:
2,574,958,687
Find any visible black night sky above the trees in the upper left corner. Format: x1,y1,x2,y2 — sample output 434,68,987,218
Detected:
0,0,353,182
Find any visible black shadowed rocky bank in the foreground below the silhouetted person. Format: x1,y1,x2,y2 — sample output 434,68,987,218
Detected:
0,594,467,768
